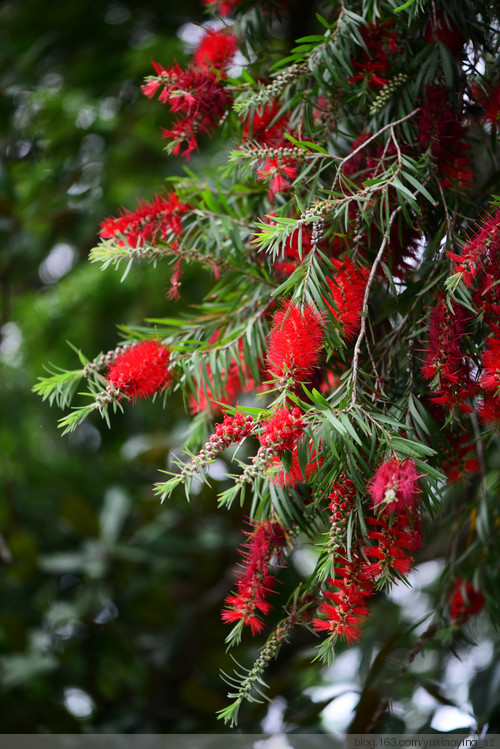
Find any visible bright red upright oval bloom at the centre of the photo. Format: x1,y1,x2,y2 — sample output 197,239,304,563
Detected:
267,300,324,383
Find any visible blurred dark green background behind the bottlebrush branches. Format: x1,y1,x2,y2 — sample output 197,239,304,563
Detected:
0,0,500,733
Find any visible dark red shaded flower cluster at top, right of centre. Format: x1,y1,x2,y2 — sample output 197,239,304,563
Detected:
349,21,400,88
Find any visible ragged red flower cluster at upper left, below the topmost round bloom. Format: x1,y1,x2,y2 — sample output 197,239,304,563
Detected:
142,62,231,159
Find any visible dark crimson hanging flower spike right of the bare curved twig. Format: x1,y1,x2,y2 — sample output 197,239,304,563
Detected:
422,299,477,411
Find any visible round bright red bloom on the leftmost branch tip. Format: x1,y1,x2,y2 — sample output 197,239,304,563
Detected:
106,341,172,403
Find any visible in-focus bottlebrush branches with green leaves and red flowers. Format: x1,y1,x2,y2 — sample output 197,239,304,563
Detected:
28,0,500,732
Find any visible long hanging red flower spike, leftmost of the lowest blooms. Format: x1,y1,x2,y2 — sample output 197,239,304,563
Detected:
222,520,286,635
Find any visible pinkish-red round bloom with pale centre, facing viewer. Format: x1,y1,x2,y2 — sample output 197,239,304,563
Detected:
368,458,420,513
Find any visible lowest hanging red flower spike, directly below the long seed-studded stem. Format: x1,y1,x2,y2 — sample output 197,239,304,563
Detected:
313,549,373,645
